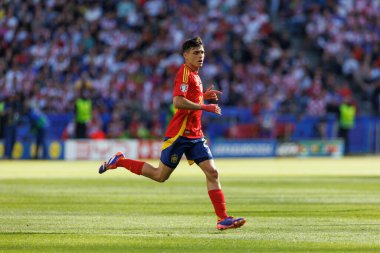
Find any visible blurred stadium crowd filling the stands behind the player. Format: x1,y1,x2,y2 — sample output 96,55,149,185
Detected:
0,0,380,142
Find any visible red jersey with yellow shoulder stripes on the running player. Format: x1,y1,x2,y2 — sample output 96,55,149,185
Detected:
165,64,203,138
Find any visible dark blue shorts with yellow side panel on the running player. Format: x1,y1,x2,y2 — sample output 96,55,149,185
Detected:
161,136,213,169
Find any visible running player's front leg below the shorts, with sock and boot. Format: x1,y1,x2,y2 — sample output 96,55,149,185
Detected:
199,159,246,230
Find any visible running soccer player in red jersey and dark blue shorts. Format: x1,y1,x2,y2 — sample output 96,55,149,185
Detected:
99,37,246,230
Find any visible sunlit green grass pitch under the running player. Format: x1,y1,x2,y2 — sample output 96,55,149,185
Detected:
0,157,380,253
